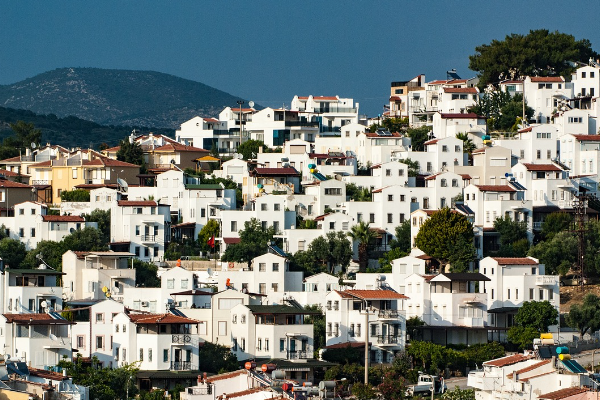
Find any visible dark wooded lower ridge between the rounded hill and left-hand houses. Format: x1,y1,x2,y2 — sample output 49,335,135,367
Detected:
0,107,174,150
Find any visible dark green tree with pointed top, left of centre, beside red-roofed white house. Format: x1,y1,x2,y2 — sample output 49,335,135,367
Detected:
222,218,275,266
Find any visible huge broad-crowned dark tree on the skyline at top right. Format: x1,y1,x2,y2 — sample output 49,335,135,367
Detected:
469,29,598,87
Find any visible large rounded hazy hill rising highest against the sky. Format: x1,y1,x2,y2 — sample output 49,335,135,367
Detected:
0,68,250,129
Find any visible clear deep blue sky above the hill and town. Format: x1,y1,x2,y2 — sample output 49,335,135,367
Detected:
0,0,600,116
